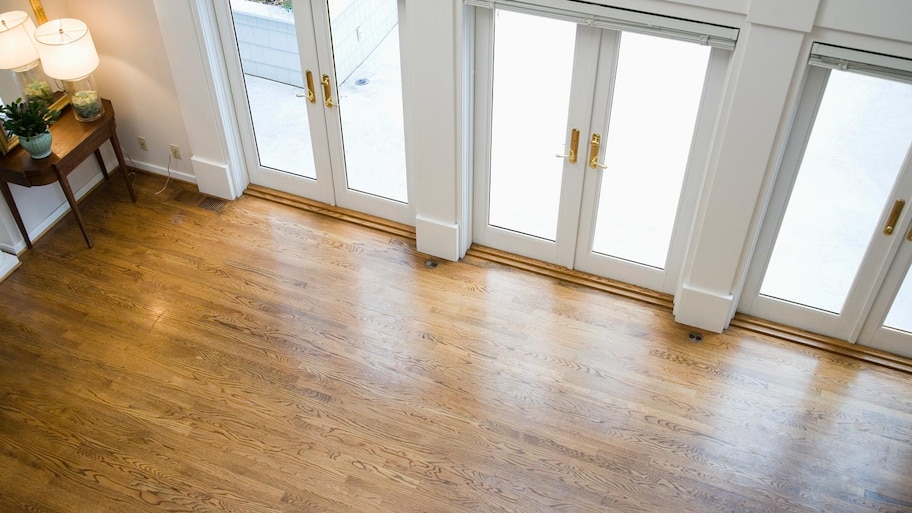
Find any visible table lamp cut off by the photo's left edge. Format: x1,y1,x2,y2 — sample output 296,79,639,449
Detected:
0,11,53,105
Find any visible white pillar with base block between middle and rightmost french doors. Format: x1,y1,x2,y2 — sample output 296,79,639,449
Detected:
675,25,807,331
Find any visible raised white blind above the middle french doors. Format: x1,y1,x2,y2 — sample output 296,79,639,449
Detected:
465,0,738,50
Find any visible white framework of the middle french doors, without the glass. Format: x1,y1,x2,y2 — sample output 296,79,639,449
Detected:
473,9,731,293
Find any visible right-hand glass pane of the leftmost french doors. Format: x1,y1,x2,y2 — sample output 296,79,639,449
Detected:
329,0,408,203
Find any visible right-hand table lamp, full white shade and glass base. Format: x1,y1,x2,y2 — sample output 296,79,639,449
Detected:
35,18,104,121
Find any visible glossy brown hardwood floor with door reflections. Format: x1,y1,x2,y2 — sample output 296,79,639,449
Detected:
0,174,912,513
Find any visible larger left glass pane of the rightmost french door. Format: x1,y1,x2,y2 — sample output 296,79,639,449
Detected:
760,71,912,314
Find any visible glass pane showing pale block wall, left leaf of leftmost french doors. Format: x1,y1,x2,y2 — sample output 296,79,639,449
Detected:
231,0,319,179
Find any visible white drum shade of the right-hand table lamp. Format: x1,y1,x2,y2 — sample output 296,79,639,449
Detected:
35,18,98,80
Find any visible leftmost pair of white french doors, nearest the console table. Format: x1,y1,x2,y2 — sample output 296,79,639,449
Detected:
215,0,414,224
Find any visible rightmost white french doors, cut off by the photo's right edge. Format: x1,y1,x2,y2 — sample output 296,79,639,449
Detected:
739,47,912,356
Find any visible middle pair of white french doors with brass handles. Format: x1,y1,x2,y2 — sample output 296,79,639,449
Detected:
473,5,730,292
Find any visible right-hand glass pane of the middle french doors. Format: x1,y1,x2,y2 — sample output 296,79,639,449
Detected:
592,32,710,269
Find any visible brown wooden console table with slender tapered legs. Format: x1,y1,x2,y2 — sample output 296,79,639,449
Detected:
0,100,136,248
